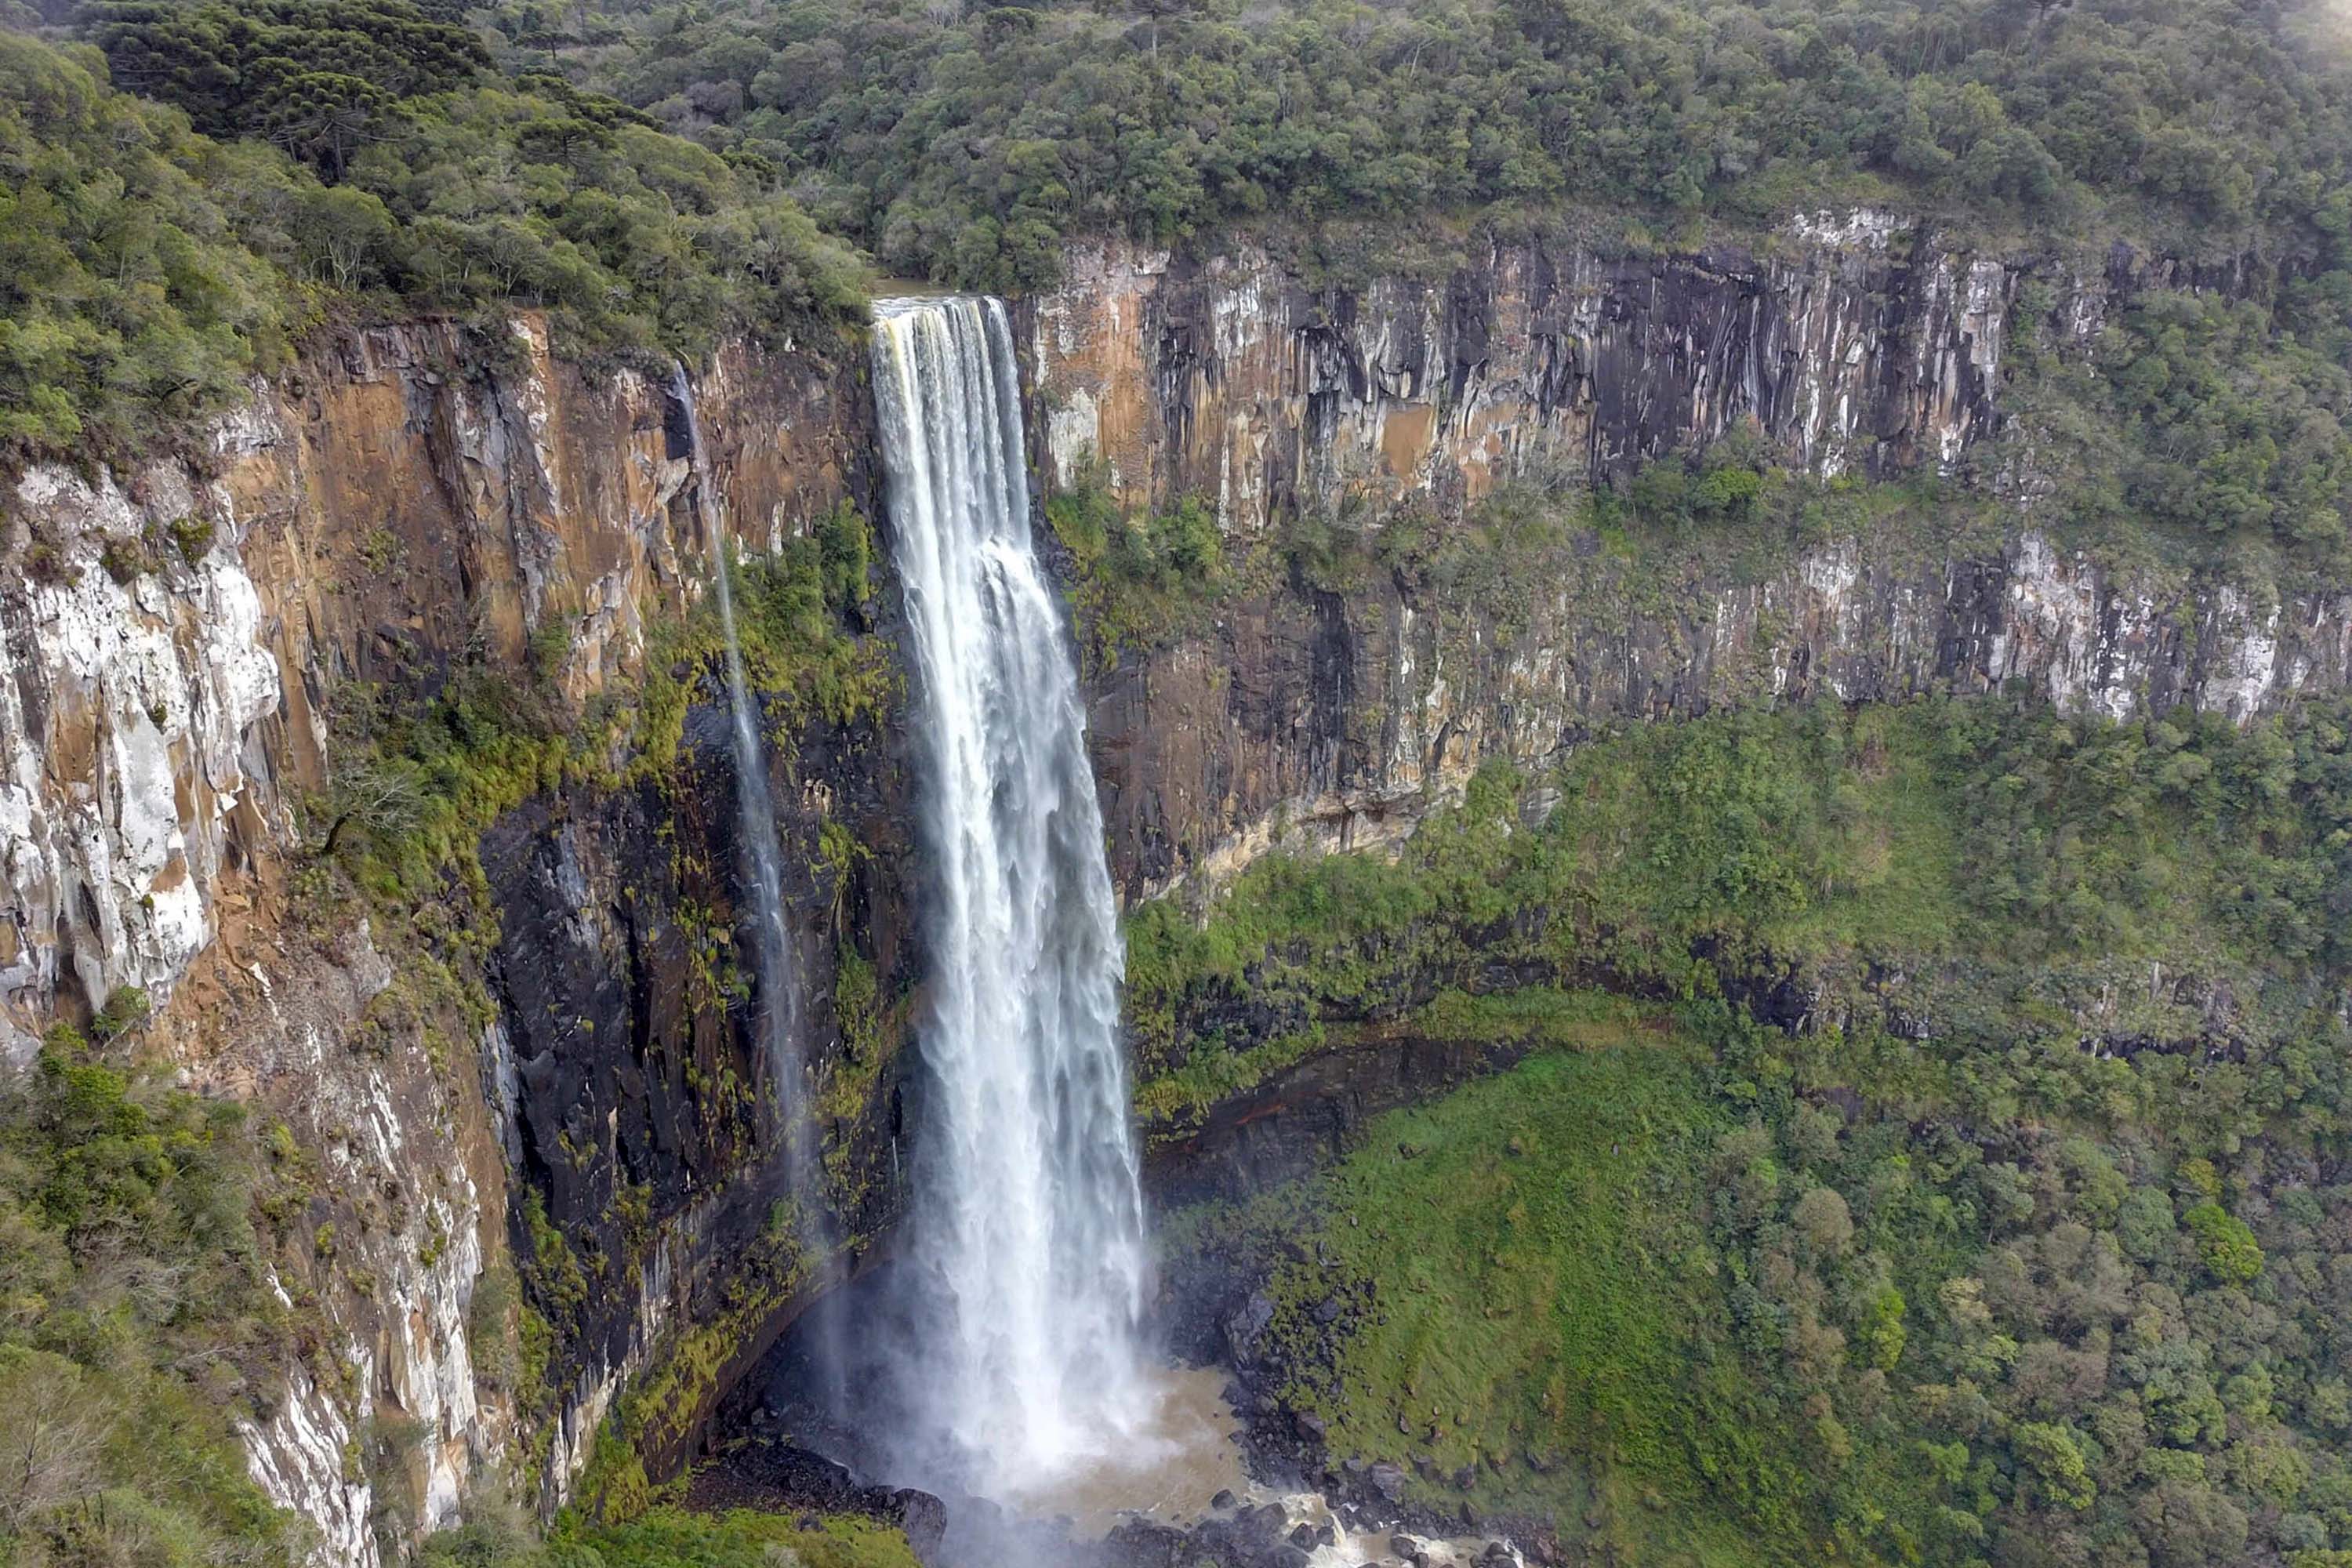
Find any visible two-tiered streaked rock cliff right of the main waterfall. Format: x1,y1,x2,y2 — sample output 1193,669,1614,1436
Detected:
1025,231,2352,895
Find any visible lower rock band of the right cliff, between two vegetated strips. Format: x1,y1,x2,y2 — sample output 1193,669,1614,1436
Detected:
1089,527,2352,898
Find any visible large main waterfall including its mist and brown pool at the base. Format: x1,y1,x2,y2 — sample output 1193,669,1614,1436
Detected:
710,299,1484,1568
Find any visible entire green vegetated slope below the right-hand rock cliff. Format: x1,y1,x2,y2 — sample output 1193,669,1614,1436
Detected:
1148,699,2352,1568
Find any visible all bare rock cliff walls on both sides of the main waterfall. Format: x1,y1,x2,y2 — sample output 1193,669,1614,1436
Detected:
0,214,2324,1563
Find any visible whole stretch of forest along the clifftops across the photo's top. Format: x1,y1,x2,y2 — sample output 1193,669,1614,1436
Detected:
0,0,2352,461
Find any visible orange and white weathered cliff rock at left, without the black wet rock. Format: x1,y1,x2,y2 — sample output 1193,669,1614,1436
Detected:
0,318,868,1568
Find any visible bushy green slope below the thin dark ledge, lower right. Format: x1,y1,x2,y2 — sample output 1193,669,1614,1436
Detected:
1185,973,2352,1568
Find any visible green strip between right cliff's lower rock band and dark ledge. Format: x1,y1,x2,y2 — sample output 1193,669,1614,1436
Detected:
1127,699,2352,1133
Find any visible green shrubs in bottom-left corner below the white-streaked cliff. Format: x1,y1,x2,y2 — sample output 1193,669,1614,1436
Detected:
0,1025,303,1568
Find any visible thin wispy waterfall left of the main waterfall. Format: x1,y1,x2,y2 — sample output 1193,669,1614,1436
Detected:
670,365,804,1114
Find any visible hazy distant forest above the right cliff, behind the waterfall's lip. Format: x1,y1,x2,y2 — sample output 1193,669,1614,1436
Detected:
477,0,2352,287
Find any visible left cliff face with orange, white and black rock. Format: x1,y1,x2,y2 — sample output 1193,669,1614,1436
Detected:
0,320,884,1563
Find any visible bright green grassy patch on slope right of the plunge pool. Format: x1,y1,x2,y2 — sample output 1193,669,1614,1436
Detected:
1275,1039,1802,1542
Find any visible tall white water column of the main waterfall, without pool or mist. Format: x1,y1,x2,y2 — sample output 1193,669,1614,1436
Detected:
873,299,1143,1497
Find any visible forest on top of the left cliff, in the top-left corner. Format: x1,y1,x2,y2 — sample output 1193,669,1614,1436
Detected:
0,10,866,461
